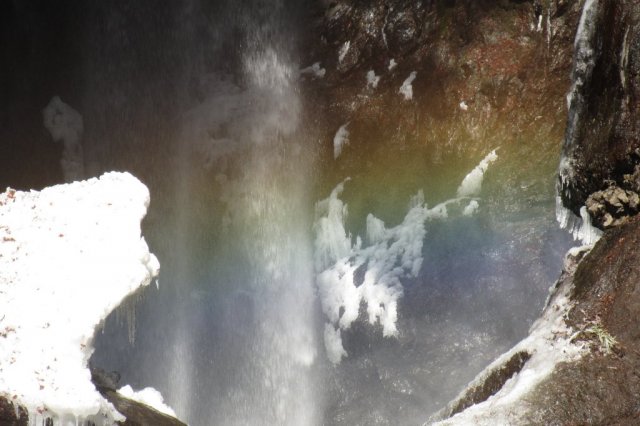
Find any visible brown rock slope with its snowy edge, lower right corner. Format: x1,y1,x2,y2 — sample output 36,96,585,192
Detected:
437,218,640,425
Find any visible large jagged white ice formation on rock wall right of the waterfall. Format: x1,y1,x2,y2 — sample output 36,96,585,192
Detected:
314,151,495,363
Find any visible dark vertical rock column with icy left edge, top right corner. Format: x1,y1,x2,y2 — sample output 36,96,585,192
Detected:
560,0,640,220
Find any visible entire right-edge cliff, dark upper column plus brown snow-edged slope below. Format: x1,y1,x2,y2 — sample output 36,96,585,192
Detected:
432,0,640,425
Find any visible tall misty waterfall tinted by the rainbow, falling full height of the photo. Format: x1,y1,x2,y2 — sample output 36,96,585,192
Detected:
160,2,322,425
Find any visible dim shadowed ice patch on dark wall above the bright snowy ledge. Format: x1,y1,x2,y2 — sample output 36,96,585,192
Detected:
42,96,84,182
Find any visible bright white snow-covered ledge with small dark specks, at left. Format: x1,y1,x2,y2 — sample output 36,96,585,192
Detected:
0,172,159,425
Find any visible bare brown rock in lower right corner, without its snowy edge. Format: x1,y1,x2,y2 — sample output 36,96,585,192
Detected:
528,218,640,425
